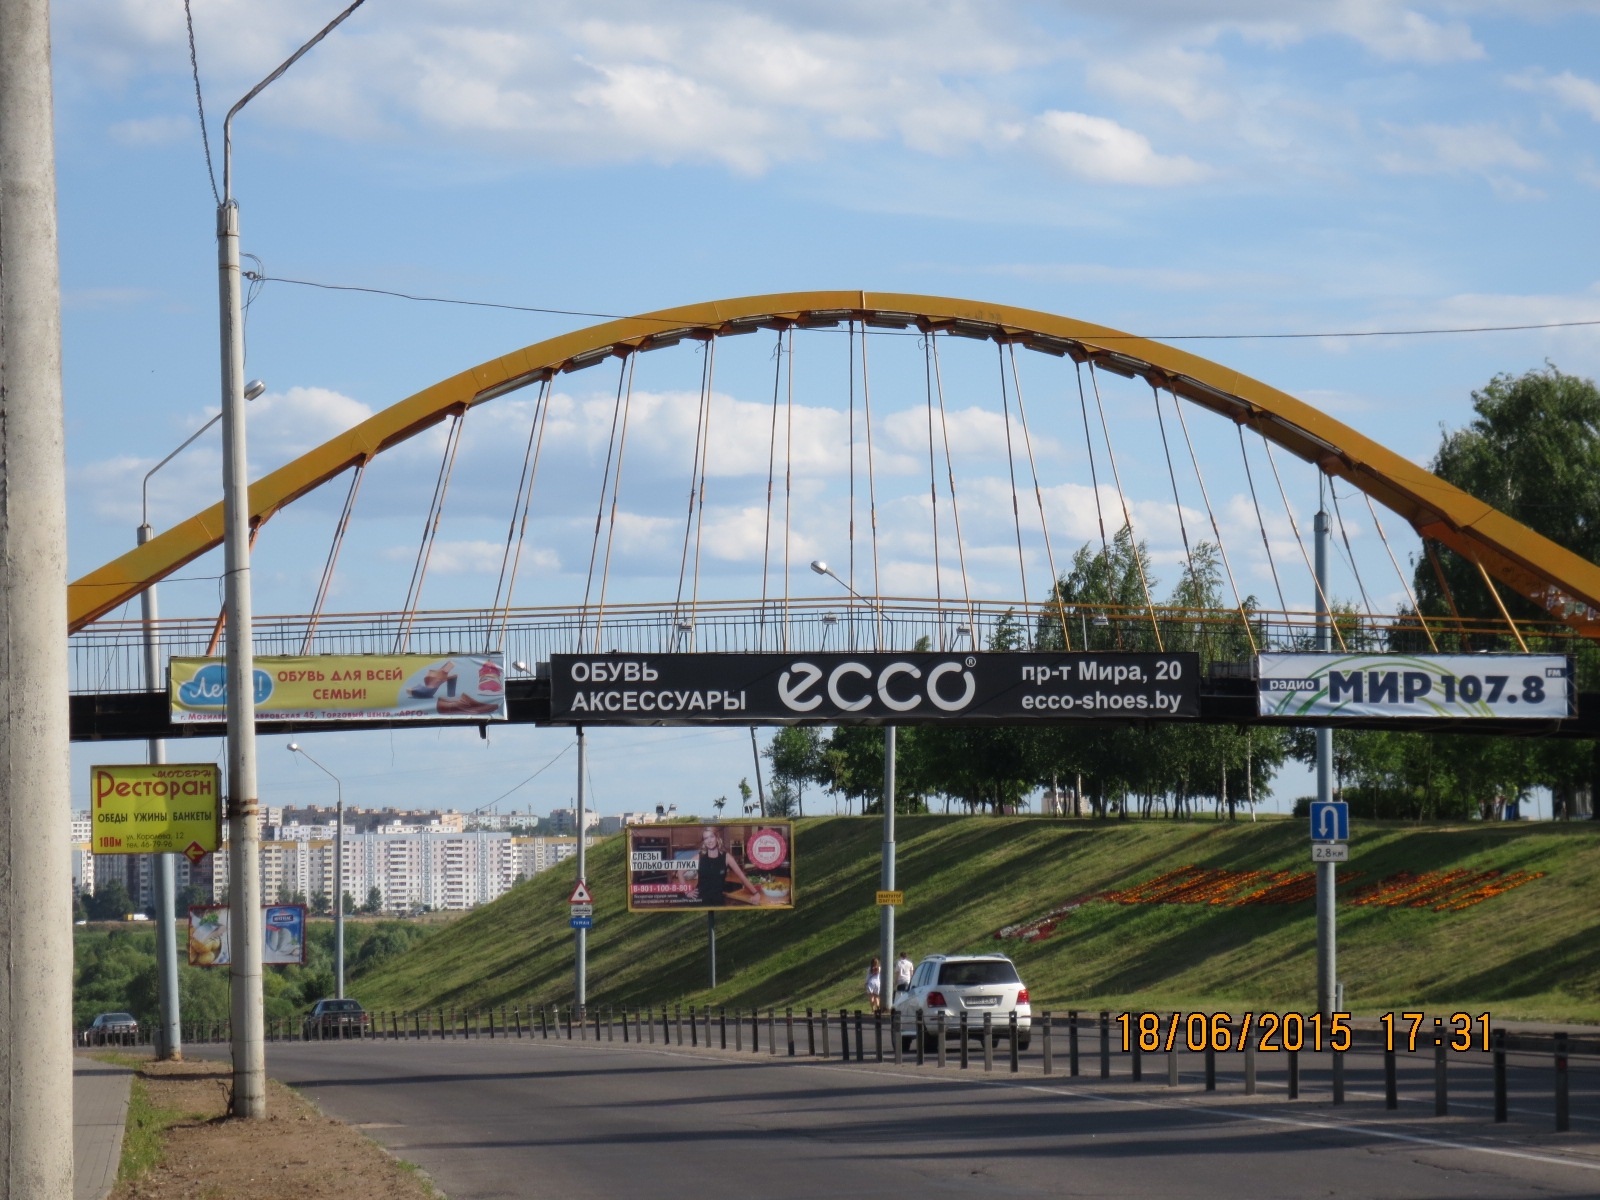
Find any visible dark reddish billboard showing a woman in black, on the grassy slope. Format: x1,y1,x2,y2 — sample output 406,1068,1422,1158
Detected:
627,821,795,912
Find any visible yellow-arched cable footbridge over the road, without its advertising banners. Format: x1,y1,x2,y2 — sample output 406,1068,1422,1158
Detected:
67,291,1600,738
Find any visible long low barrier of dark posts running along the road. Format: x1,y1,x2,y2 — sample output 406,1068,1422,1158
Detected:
165,1003,1600,1133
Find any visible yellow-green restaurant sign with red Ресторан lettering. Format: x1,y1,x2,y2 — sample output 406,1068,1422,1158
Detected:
90,763,222,858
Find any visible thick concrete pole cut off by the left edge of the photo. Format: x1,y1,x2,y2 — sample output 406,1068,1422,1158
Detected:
0,0,72,1200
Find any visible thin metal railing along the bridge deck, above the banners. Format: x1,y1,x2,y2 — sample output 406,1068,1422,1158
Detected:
69,597,1576,693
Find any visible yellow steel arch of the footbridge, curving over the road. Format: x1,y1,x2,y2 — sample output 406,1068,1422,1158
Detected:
67,291,1600,638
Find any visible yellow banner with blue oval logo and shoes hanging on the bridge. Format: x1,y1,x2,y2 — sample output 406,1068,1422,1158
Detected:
166,654,506,725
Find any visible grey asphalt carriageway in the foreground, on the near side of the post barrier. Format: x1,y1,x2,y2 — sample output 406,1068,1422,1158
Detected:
194,1038,1600,1200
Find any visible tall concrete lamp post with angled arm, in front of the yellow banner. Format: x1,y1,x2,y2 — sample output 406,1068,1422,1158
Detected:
216,0,363,1120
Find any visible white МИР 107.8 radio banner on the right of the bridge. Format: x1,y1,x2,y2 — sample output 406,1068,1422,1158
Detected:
1256,654,1576,720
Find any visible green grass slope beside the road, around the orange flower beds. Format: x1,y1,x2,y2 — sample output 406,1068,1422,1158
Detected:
350,816,1600,1021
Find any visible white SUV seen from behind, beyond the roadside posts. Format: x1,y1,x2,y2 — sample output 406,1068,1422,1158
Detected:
894,954,1034,1051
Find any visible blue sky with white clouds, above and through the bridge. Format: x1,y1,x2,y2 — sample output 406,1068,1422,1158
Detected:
54,0,1600,813
